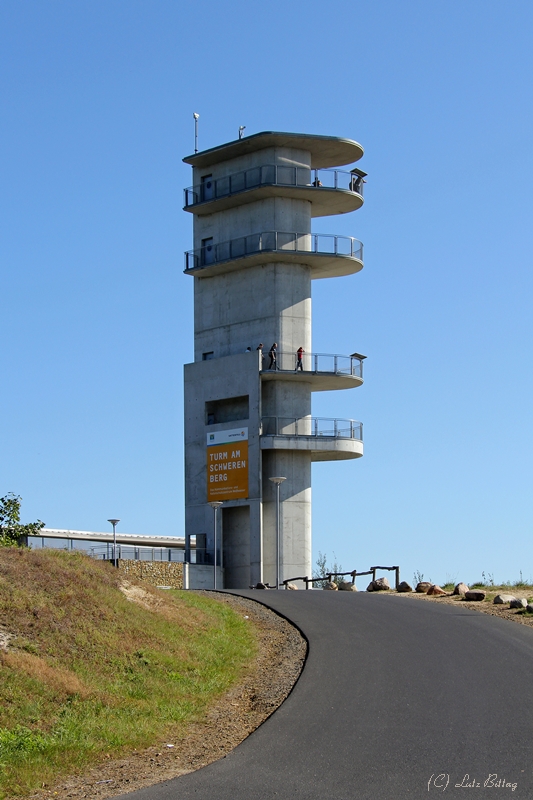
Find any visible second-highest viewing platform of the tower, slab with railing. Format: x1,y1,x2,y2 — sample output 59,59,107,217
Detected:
184,231,363,278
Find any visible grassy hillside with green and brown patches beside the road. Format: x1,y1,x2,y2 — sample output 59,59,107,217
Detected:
0,548,256,800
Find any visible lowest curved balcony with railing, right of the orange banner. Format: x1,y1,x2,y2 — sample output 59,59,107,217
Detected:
261,417,363,461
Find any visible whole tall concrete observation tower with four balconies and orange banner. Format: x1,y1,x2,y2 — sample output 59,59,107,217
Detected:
184,132,366,588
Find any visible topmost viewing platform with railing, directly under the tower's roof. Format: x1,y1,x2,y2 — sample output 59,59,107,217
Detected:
184,164,366,217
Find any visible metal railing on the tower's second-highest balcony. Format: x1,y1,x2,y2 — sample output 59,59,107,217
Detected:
185,231,363,271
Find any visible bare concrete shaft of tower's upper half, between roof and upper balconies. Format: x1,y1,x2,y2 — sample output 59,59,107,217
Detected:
194,148,311,361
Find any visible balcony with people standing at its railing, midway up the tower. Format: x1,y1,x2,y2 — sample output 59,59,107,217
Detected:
260,350,366,392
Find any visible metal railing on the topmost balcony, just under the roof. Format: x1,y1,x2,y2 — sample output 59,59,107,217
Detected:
183,164,364,208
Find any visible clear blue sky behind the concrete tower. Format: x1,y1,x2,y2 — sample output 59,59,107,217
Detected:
0,0,533,582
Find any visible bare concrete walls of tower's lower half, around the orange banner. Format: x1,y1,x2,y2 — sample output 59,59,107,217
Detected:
184,330,311,588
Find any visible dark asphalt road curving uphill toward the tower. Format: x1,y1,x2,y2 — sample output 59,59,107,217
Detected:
120,591,533,800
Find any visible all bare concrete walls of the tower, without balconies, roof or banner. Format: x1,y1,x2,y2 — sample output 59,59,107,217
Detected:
185,148,312,588
